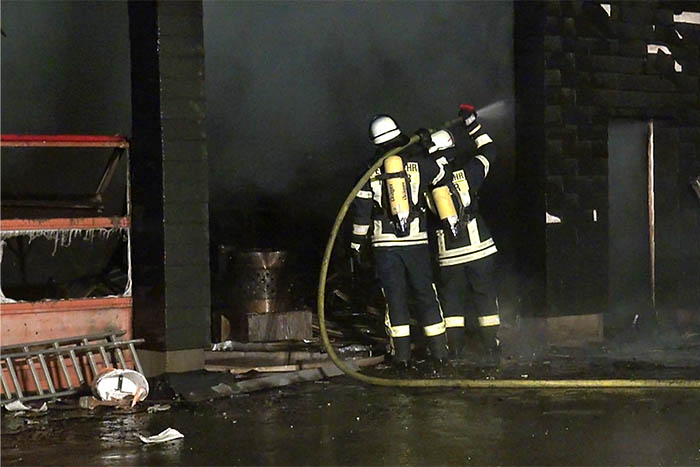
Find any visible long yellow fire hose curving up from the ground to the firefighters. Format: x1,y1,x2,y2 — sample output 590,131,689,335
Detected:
317,122,700,389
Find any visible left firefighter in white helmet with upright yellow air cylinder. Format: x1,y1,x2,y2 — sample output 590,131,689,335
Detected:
350,115,447,368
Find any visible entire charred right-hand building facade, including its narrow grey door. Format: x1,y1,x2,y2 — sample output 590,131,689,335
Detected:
514,2,700,335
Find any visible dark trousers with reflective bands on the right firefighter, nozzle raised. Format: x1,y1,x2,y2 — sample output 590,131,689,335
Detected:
440,255,501,355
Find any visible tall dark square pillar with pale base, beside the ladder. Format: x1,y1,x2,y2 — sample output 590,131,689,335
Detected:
129,1,211,375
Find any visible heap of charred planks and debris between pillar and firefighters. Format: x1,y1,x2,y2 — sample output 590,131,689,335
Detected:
202,254,388,400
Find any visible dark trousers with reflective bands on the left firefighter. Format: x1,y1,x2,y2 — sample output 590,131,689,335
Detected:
374,245,447,362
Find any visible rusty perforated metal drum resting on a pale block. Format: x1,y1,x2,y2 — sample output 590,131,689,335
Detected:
234,250,289,314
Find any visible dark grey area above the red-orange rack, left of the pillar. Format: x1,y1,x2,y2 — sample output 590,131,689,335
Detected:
0,1,131,134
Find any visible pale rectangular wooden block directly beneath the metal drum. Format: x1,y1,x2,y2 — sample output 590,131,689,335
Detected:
248,310,313,342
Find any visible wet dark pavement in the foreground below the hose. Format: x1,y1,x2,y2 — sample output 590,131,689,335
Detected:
0,376,700,465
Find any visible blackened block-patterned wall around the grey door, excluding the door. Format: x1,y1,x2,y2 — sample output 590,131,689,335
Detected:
515,1,700,328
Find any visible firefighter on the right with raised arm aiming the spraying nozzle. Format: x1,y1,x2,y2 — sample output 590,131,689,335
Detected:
431,105,500,358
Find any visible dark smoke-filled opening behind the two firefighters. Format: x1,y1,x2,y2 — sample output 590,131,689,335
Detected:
204,2,515,280
